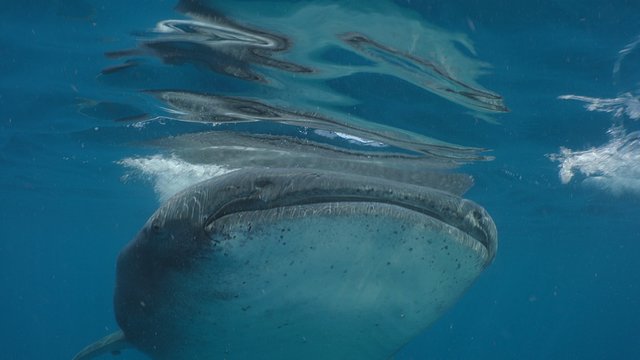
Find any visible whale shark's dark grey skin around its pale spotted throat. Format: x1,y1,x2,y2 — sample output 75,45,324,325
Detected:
74,169,497,360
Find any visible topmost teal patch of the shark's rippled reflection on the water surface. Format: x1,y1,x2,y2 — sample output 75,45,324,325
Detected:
103,1,508,113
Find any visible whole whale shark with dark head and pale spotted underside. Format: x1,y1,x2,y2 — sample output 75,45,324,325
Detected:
74,168,497,360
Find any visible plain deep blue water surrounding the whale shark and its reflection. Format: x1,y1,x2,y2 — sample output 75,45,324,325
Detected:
0,0,640,359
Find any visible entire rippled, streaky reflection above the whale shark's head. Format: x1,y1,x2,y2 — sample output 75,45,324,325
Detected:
101,1,508,193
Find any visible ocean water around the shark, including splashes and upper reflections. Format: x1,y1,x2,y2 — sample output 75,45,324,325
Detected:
0,0,640,359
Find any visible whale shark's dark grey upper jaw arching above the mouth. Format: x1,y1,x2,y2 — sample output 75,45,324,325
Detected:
145,168,497,264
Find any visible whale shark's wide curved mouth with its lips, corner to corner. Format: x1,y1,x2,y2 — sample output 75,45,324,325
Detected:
204,171,496,262
